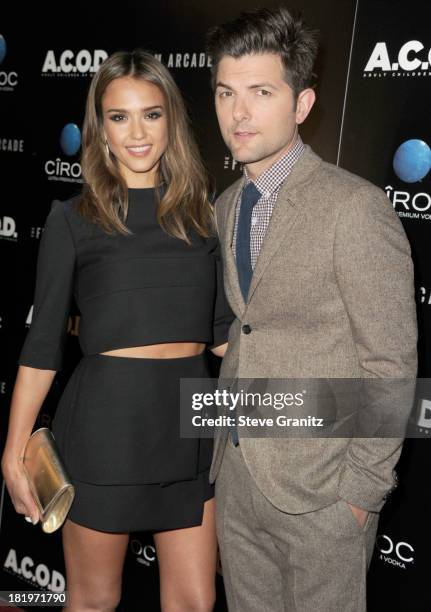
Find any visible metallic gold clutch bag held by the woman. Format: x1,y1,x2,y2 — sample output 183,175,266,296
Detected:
23,427,75,533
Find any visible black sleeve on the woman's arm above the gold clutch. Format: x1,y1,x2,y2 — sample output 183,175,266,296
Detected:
18,200,75,370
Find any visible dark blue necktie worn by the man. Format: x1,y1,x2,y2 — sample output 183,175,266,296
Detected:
235,181,261,302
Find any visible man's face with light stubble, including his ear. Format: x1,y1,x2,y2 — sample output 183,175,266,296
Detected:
215,53,314,178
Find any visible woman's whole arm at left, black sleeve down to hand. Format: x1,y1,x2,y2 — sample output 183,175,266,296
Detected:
1,202,76,522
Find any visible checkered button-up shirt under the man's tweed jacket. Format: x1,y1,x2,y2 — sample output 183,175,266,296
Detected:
232,135,305,270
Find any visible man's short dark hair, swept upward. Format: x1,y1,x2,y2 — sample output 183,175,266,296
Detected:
207,7,318,97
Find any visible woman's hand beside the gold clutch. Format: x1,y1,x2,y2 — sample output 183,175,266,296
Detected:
2,455,40,525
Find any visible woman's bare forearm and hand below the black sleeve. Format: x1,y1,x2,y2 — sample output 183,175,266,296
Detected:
1,366,55,523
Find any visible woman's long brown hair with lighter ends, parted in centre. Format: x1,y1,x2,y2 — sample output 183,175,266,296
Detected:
79,49,214,243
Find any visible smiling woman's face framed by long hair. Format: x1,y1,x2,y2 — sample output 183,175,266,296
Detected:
102,77,168,188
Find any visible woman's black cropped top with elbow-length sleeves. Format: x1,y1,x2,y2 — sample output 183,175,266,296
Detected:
18,189,234,370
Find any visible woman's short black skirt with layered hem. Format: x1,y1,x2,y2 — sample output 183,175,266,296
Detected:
52,352,214,533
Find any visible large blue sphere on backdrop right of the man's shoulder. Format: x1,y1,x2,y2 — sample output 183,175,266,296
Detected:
393,139,431,183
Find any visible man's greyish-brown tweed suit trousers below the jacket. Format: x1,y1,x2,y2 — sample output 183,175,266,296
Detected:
216,440,379,612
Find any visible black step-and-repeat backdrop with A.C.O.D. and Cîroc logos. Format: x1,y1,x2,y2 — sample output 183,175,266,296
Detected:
0,0,431,612
